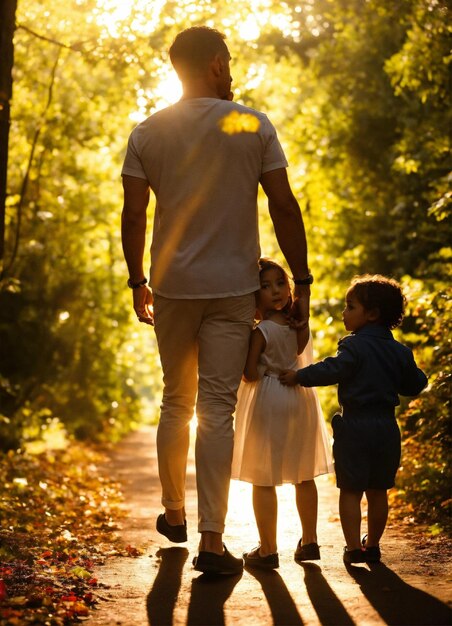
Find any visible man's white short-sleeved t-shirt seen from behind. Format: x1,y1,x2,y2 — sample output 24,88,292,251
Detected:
122,98,287,298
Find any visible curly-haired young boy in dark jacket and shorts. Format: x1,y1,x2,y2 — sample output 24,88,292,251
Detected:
280,275,427,564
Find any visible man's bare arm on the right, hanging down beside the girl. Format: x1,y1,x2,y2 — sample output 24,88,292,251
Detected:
260,168,311,326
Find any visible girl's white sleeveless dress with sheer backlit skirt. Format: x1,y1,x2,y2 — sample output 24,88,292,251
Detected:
232,320,333,486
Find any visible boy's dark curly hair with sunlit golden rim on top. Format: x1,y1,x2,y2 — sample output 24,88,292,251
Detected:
348,274,406,328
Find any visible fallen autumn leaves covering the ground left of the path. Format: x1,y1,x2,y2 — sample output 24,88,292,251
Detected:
0,445,134,626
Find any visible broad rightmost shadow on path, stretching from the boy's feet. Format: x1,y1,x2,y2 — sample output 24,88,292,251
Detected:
347,563,452,626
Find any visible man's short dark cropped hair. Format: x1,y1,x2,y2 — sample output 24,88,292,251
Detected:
169,26,228,76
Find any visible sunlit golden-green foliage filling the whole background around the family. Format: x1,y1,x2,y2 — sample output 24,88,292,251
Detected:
0,0,451,523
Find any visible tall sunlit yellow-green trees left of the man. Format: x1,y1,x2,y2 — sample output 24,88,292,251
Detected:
0,3,159,449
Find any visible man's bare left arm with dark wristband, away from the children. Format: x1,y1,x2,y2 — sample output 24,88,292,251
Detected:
121,175,153,324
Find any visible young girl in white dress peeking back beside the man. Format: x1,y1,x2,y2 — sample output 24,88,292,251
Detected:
232,259,332,569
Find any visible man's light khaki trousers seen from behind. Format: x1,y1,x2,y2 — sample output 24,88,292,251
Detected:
154,293,256,533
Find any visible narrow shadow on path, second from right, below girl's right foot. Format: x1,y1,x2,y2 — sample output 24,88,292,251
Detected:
300,563,356,626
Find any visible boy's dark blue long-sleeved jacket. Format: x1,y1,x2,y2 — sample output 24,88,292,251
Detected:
297,324,428,410
